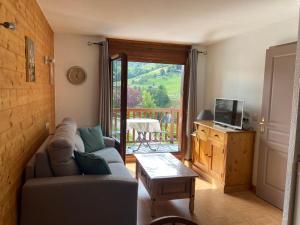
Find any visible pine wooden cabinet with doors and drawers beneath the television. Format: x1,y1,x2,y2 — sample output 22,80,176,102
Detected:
192,121,255,192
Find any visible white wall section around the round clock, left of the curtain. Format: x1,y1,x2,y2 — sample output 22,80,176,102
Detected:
54,34,102,126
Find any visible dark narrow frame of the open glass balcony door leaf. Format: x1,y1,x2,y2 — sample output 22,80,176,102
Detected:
109,53,128,163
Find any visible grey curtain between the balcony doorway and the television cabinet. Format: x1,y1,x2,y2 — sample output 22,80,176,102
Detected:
185,49,198,160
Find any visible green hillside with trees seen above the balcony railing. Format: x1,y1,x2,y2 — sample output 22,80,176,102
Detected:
127,62,184,108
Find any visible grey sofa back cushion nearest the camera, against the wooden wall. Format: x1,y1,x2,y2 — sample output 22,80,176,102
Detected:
48,121,80,176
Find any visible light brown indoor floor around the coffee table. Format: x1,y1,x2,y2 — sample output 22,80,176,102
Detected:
127,163,282,225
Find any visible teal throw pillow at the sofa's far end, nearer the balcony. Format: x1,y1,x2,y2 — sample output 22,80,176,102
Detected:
79,125,105,152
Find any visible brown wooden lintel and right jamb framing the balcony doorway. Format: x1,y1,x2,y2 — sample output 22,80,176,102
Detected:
107,38,192,161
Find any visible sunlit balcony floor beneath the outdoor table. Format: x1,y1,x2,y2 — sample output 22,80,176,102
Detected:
126,142,179,155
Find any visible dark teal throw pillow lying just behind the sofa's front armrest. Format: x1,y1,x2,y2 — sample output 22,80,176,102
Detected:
74,151,111,175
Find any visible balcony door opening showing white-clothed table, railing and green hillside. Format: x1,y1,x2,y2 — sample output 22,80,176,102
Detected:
127,62,184,154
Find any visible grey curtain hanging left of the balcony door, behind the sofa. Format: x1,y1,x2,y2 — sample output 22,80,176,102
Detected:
99,41,112,136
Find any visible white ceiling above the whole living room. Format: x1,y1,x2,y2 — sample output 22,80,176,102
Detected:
38,0,300,44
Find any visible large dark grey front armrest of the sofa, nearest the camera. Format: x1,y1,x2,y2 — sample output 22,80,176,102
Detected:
21,175,138,225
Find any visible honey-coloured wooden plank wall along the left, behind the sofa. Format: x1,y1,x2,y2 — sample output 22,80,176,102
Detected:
0,0,54,225
